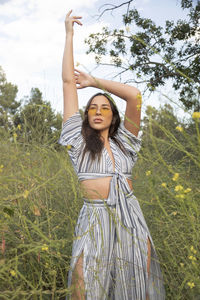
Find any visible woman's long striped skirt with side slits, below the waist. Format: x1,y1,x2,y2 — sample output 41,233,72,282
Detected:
68,192,165,300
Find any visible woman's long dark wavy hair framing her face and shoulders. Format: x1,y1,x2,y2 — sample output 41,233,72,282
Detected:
81,93,126,160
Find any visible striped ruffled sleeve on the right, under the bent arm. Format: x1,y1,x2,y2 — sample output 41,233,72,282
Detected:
117,122,142,156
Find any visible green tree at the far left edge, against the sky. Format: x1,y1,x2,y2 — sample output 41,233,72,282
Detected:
0,67,21,130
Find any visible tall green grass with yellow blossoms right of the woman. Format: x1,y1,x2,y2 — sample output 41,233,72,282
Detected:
133,107,200,300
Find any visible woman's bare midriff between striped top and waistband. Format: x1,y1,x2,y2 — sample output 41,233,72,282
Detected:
81,177,133,199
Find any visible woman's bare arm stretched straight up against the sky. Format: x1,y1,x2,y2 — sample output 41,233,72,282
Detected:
62,10,82,122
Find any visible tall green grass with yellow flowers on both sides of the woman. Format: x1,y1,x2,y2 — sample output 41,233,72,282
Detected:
0,111,200,300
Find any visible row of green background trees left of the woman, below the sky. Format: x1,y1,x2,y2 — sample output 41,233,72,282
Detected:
0,67,62,148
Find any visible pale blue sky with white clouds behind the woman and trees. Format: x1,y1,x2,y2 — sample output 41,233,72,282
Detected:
0,0,191,119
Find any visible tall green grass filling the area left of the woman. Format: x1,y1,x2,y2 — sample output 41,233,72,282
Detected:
0,140,82,300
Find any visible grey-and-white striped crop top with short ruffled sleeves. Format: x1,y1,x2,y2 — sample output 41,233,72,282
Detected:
58,112,141,181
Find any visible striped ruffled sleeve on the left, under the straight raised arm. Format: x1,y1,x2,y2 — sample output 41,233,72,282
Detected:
58,111,83,156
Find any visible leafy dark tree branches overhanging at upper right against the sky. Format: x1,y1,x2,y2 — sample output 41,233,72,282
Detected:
85,0,200,111
